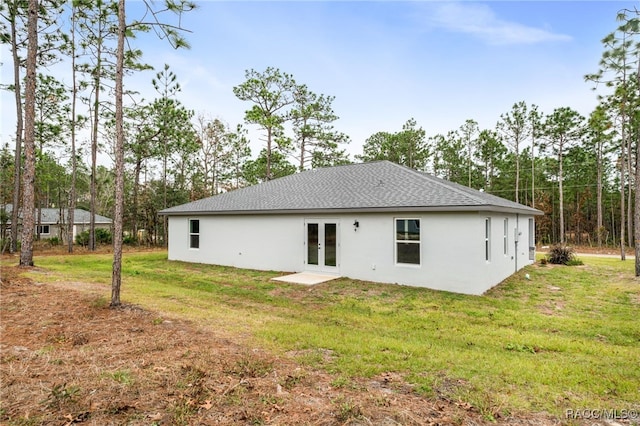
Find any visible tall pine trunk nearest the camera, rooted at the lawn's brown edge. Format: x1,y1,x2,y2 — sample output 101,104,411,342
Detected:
111,0,126,307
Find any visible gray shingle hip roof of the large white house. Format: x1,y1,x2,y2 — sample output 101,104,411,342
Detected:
160,161,542,216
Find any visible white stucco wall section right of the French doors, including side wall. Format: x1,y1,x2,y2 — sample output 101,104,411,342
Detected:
340,212,533,294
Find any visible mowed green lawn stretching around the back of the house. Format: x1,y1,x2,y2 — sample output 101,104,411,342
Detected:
28,252,640,418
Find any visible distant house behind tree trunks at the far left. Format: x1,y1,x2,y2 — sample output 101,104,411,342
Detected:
4,204,112,240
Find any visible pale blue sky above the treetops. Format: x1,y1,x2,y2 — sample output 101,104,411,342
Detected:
0,1,640,161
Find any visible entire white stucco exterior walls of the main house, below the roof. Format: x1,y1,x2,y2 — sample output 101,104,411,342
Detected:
169,212,533,294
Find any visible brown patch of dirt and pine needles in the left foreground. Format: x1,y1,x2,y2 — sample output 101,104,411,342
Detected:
0,255,616,425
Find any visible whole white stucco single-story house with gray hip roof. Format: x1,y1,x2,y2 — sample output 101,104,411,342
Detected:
160,161,542,294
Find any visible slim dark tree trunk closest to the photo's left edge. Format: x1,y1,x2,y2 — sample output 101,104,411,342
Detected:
9,2,23,253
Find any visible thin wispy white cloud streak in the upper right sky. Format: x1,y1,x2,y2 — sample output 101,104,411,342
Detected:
428,2,572,45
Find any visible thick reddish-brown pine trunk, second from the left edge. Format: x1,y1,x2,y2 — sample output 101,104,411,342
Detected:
16,0,38,266
